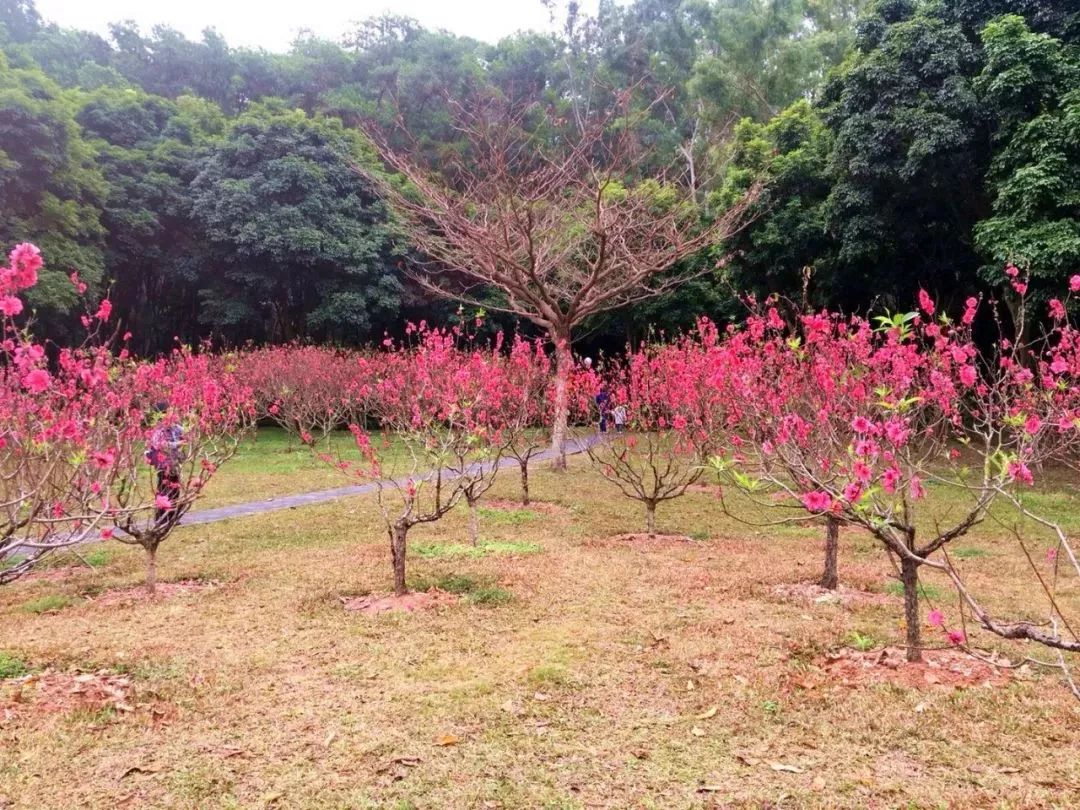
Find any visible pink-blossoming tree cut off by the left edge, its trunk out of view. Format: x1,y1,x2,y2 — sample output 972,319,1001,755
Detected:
0,243,125,582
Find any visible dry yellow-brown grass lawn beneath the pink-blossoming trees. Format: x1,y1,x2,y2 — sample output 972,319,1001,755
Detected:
0,434,1080,809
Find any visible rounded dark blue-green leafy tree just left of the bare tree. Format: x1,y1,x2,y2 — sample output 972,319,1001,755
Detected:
192,104,401,341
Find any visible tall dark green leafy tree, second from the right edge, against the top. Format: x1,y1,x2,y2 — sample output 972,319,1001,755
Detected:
825,0,987,306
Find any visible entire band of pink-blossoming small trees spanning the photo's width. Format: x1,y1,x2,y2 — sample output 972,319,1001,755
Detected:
0,244,1080,699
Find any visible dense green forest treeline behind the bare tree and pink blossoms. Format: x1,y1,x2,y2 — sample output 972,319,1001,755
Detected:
0,0,1080,352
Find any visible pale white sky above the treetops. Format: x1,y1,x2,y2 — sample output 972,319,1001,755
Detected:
37,0,596,51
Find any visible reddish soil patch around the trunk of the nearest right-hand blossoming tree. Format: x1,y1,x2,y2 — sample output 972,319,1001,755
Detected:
807,647,1012,689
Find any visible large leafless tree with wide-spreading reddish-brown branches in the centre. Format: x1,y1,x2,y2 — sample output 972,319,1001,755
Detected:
362,87,757,469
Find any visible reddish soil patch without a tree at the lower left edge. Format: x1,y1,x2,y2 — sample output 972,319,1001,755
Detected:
0,670,135,720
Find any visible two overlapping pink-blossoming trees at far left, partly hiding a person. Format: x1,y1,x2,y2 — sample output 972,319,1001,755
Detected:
0,243,254,592
